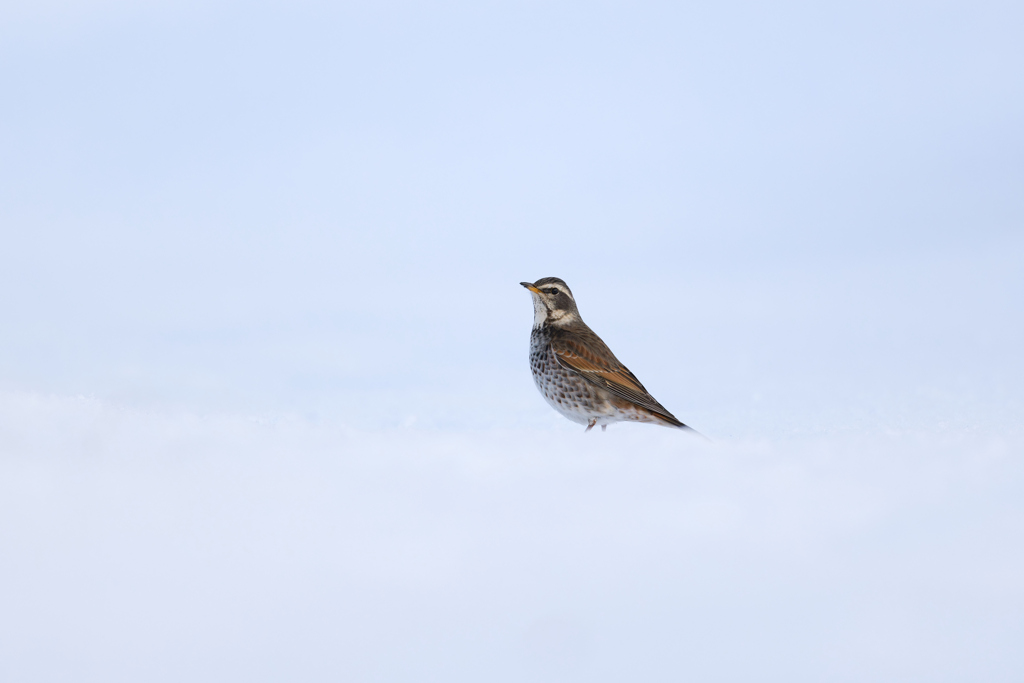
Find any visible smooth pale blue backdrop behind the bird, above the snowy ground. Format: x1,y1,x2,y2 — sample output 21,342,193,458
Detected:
0,3,1024,433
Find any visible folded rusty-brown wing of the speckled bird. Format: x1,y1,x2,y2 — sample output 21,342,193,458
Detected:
551,329,684,427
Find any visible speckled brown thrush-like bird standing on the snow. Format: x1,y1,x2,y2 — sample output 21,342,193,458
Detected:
519,278,699,434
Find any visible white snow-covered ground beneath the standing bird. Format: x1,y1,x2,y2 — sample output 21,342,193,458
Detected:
0,394,1024,681
